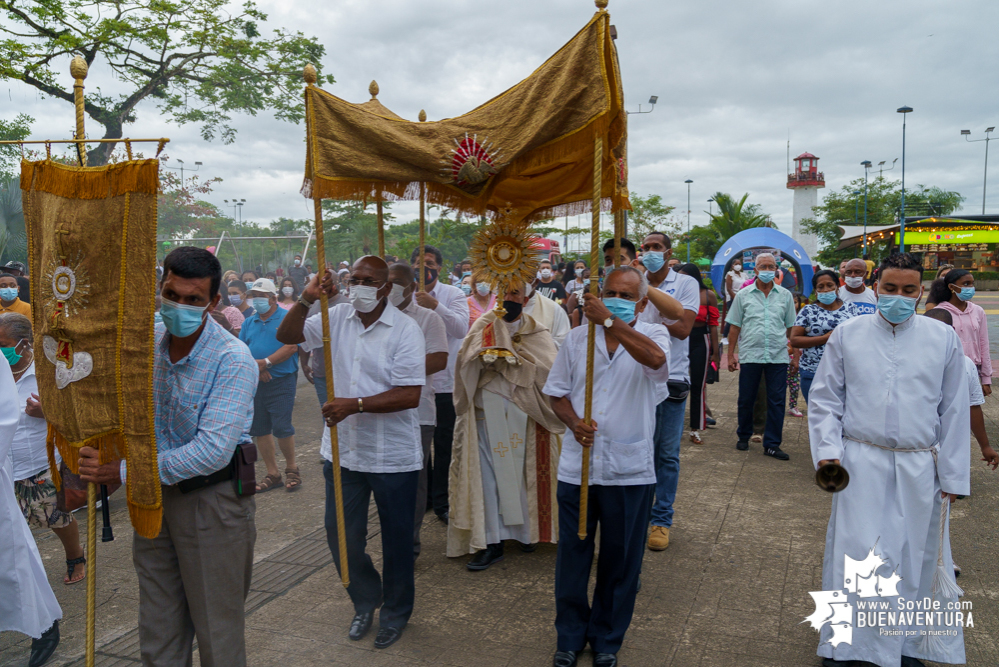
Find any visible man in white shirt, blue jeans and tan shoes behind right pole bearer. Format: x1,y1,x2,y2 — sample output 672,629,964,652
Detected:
629,232,701,551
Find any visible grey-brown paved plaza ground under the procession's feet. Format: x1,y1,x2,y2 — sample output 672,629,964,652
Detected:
0,294,999,667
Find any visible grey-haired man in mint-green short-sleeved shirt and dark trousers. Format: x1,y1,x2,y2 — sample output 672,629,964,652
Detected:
728,252,797,461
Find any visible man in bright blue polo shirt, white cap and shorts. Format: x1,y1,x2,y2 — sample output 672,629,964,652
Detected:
239,278,302,493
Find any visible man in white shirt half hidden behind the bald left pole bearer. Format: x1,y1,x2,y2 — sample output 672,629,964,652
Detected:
388,263,448,556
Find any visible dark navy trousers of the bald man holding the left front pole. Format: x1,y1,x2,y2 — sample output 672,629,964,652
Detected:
323,461,420,628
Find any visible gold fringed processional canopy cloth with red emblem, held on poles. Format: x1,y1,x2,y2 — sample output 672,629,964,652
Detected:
302,11,630,221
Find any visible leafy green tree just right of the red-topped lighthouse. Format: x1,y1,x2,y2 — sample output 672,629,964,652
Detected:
801,176,964,265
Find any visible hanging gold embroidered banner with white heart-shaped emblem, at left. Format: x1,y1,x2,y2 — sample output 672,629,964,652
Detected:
21,160,161,538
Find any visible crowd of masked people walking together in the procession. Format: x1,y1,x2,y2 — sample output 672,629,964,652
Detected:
0,240,999,667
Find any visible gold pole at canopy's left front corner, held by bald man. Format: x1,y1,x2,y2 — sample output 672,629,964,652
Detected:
302,63,350,588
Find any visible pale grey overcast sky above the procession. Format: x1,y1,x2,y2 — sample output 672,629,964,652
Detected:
0,0,999,248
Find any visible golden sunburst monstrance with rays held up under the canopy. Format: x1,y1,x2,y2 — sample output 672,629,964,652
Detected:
469,220,540,312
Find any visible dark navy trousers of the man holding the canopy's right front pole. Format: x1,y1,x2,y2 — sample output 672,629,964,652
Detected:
555,482,653,653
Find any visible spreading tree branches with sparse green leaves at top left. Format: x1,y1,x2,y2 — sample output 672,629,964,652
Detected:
0,0,333,164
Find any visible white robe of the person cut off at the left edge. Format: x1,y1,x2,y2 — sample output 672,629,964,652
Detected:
0,358,62,639
